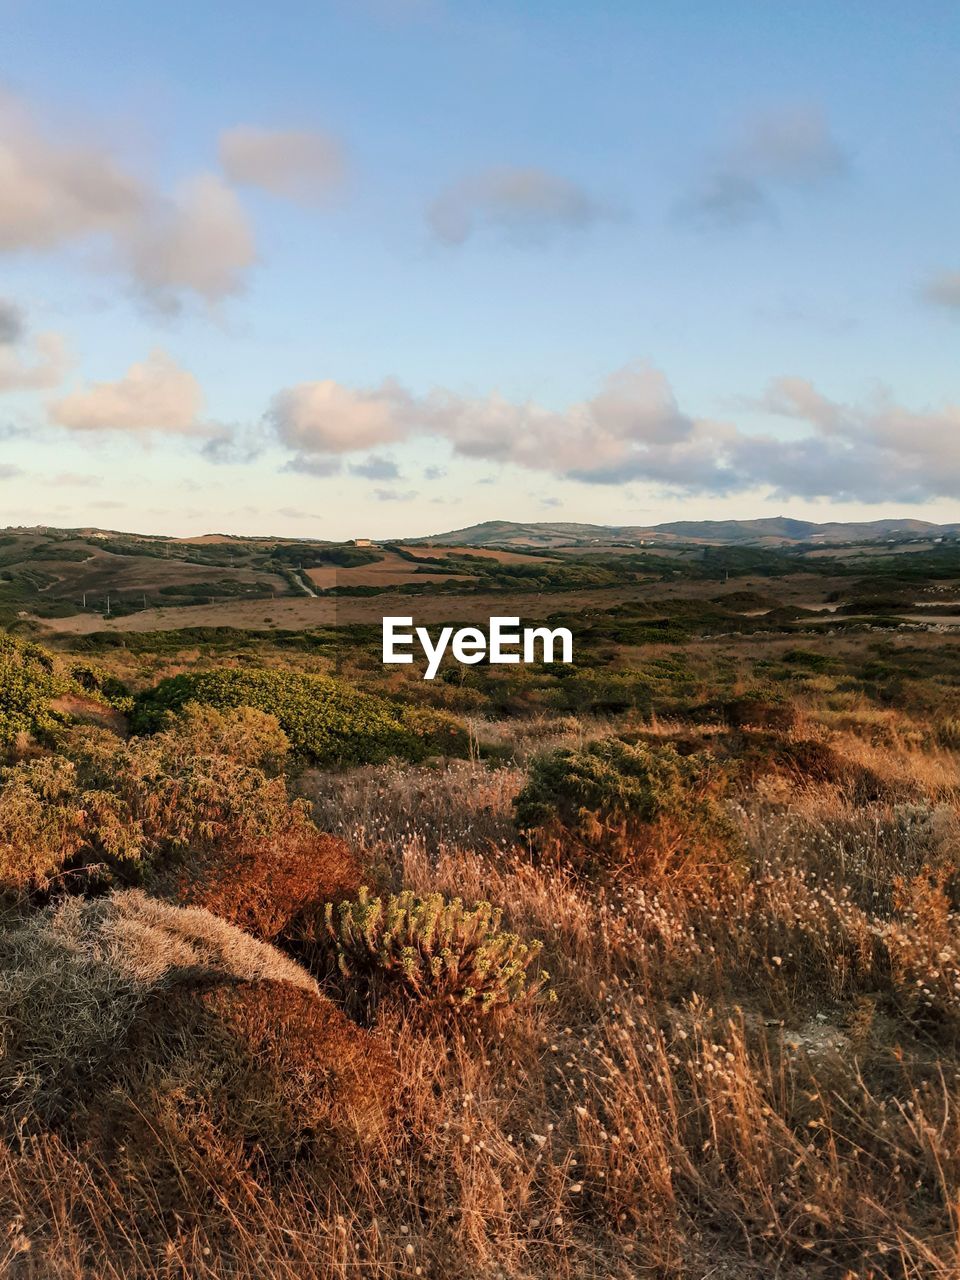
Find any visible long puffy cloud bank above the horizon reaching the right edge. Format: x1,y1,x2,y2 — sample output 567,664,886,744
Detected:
266,364,960,503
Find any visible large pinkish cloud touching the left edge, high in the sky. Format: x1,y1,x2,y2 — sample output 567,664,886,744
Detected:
0,95,255,307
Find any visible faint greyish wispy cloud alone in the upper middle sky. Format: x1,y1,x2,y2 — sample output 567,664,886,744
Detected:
426,168,611,244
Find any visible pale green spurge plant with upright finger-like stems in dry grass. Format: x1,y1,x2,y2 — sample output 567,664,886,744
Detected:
324,888,549,1011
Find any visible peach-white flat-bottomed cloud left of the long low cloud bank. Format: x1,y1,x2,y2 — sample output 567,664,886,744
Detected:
50,351,204,435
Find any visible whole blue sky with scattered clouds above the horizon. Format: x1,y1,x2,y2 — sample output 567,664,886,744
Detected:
0,0,960,539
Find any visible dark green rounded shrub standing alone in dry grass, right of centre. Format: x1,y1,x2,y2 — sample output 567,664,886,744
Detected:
513,739,728,861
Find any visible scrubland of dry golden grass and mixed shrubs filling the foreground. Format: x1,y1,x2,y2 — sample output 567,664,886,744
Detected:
0,614,960,1280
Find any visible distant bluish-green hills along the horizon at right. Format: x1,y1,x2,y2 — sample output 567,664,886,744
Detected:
407,516,960,547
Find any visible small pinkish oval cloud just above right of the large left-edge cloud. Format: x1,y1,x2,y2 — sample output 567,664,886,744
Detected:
220,125,346,205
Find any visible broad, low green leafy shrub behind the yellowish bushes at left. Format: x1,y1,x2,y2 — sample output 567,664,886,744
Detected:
133,668,467,764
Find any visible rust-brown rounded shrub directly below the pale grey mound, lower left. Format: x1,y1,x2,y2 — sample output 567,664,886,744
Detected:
96,982,394,1177
